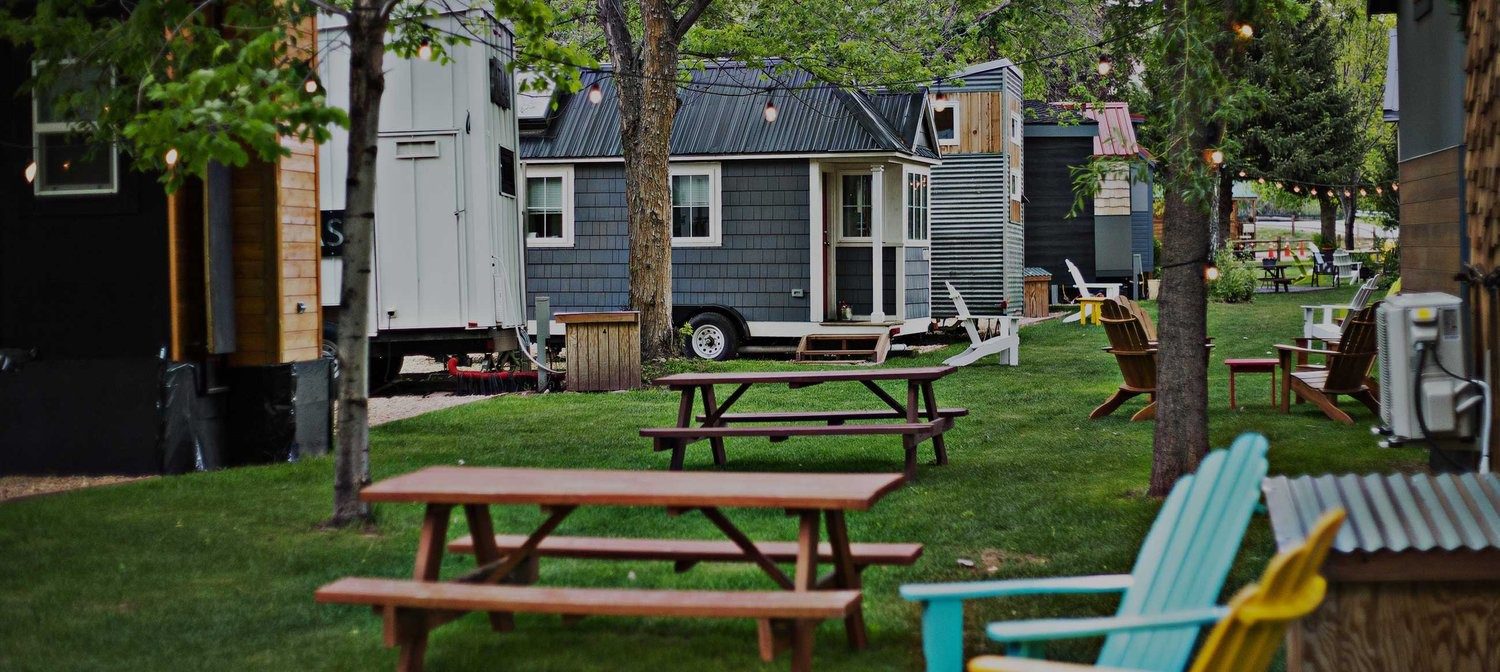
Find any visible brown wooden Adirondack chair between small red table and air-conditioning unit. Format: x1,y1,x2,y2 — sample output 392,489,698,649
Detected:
1277,302,1380,425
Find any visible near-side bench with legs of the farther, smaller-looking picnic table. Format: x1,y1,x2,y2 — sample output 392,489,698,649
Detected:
641,411,953,477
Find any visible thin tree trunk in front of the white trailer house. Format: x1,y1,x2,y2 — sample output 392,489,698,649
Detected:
329,0,387,527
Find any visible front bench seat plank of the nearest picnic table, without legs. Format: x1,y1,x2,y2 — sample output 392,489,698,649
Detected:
314,578,860,618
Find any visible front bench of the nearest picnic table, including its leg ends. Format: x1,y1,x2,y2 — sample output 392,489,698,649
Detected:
314,578,860,672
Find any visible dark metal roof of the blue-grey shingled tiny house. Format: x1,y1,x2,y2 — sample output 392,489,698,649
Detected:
521,63,938,159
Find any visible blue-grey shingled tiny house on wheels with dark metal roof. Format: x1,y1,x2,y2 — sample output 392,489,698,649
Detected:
521,63,939,359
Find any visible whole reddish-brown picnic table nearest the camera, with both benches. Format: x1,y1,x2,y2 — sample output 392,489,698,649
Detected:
315,467,921,671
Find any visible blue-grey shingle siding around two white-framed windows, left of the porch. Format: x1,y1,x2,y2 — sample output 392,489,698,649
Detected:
527,161,810,323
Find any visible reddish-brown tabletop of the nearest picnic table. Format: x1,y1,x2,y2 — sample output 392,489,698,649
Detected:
360,467,903,510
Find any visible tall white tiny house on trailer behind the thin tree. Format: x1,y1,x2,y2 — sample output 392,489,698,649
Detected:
318,9,525,377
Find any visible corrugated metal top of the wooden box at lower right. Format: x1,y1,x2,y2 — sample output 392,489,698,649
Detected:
1263,474,1500,554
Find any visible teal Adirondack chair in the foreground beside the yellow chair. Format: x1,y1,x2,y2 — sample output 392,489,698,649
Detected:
902,434,1268,672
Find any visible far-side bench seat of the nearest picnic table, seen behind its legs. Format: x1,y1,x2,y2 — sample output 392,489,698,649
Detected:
449,534,923,566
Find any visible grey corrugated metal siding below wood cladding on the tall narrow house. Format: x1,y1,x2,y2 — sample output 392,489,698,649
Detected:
932,155,1020,317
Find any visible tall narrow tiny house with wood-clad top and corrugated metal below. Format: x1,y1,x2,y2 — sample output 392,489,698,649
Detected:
930,59,1026,317
